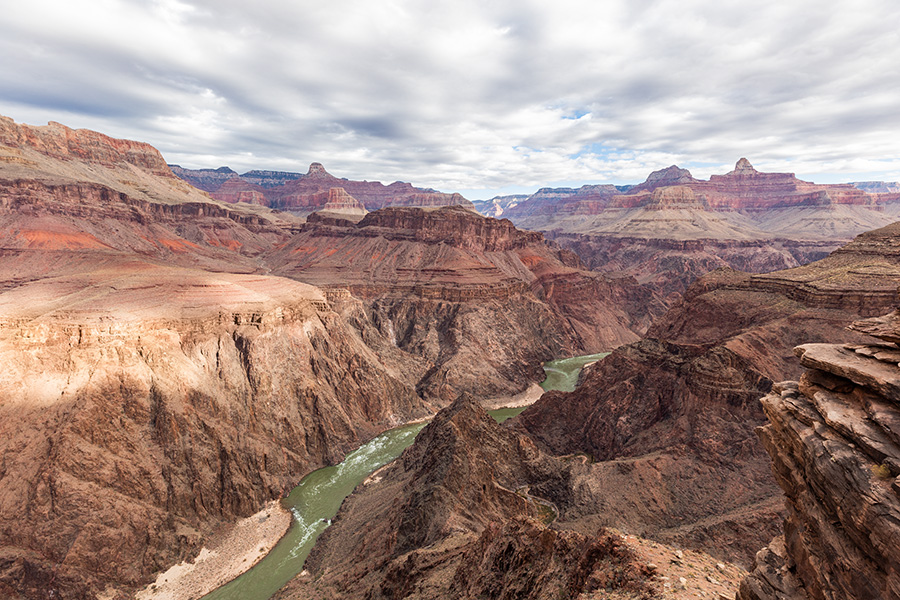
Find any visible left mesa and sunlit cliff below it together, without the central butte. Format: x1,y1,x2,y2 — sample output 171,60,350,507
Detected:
0,119,428,598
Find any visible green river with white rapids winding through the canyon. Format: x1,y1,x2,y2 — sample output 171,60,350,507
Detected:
202,353,606,600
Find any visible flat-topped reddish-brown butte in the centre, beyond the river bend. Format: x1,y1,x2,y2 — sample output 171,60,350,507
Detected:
267,207,658,402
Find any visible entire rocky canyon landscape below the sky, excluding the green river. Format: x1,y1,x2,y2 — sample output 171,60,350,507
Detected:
0,117,900,600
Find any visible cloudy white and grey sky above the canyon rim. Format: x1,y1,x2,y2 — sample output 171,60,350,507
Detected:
0,0,900,199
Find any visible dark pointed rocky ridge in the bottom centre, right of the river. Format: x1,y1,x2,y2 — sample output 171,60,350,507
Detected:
276,397,650,600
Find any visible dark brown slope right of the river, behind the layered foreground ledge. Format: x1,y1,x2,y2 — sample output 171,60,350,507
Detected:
518,226,900,564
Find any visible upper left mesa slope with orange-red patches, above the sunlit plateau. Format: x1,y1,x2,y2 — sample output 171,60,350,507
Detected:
0,117,300,285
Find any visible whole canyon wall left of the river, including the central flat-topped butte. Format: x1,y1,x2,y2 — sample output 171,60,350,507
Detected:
0,118,647,598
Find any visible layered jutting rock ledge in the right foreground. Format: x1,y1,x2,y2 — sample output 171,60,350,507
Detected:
737,311,900,600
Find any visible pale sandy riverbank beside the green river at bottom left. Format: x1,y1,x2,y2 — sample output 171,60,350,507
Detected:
135,500,291,600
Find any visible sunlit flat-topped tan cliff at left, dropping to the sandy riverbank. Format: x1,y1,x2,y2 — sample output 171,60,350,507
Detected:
0,265,424,598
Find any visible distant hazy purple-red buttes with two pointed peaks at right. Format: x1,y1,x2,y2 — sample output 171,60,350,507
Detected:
486,158,900,305
